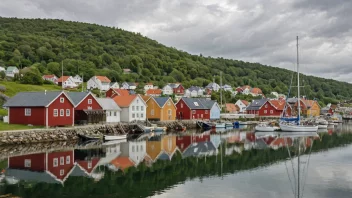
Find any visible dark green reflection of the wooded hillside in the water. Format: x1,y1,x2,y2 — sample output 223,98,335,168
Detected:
0,133,352,198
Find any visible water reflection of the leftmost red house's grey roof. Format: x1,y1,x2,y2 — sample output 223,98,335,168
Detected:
5,168,61,184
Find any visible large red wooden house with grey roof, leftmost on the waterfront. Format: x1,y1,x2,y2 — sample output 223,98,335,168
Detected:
3,91,74,127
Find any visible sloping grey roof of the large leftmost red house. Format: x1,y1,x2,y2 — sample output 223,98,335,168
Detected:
3,91,62,107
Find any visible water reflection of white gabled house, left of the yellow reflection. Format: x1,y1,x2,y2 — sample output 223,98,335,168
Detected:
120,141,147,166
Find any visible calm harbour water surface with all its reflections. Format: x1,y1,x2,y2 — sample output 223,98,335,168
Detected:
0,123,352,198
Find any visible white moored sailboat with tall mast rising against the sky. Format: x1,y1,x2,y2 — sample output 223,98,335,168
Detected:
279,36,318,132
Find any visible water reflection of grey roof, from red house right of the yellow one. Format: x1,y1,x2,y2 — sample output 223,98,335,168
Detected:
182,142,216,157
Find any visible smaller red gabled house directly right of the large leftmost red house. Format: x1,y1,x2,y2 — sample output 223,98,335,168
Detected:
67,92,105,123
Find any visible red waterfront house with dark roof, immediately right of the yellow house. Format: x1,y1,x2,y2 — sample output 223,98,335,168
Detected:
176,98,210,120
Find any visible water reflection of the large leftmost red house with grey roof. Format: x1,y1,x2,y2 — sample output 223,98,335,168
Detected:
6,151,74,184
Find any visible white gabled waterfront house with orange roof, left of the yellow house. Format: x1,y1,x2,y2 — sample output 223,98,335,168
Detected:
114,94,147,122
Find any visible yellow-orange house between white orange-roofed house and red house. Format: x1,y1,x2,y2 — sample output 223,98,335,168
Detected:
143,97,176,121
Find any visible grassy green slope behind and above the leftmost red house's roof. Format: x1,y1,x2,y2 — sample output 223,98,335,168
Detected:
0,81,61,97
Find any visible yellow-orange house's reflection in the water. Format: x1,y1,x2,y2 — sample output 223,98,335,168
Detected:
147,135,177,162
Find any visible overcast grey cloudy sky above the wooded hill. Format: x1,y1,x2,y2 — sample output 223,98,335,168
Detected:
0,0,352,82
